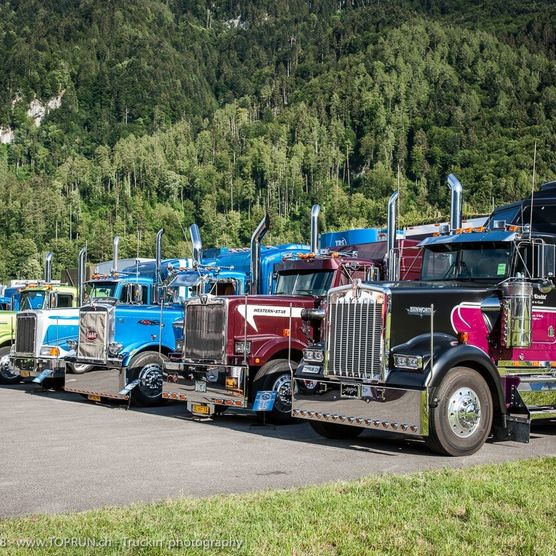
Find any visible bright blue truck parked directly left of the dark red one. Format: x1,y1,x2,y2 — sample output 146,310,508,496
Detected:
64,216,309,405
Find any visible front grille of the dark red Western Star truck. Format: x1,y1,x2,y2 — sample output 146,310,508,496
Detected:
184,302,227,363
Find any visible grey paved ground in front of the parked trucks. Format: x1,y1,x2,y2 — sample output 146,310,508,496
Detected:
0,385,556,516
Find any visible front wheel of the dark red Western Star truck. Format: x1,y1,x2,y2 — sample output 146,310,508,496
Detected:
251,359,297,425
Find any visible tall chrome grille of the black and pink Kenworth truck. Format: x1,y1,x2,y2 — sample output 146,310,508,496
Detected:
327,297,383,380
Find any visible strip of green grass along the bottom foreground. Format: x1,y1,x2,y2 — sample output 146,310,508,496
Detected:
0,458,556,556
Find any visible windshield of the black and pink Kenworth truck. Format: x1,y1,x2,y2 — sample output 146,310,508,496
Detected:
421,244,511,281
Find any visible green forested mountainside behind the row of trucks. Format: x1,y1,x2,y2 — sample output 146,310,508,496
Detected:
0,0,556,280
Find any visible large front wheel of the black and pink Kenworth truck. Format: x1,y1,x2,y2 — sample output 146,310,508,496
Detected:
427,367,493,456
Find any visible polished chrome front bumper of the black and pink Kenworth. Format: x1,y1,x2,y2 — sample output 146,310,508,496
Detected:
292,378,429,436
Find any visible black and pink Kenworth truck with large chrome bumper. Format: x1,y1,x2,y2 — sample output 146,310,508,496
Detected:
292,177,556,456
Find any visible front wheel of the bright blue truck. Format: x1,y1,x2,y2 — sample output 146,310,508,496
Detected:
128,351,168,406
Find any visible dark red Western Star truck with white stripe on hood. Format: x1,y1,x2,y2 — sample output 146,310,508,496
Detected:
163,193,428,423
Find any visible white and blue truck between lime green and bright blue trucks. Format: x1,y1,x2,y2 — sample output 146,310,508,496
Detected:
10,237,161,387
